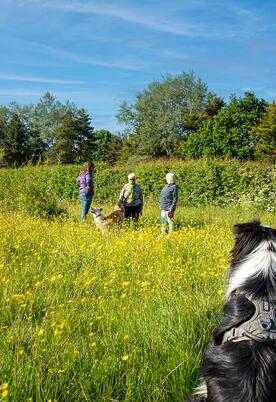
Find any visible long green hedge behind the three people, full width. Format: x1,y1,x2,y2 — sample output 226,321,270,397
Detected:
0,159,276,215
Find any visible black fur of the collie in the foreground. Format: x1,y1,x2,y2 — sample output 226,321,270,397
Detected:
184,221,276,402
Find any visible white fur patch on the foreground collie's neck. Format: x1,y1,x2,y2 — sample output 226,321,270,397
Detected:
226,240,276,298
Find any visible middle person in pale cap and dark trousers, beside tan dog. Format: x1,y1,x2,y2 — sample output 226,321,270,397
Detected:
119,173,144,227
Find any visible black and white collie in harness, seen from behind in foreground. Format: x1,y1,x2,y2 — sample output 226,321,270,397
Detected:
187,221,276,402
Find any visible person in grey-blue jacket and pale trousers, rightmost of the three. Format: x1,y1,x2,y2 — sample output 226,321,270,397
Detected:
159,173,178,235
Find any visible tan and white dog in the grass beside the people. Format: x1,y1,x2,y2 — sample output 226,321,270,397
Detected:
91,201,125,231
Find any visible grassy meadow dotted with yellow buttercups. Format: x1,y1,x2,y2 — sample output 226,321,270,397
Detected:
0,204,275,402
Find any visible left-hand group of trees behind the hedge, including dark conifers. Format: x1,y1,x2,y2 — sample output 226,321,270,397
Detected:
0,92,122,167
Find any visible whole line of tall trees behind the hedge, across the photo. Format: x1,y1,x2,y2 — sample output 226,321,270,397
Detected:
0,72,276,166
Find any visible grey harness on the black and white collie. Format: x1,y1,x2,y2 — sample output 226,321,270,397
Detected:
221,296,276,345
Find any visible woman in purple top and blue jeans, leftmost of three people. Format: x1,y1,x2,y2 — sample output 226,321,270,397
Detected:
77,161,94,223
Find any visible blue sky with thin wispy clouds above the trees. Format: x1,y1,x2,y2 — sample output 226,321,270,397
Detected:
0,0,276,133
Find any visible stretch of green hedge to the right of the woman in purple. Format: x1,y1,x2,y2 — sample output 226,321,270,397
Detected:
91,159,276,211
